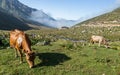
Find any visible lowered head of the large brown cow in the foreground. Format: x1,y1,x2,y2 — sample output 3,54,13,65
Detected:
25,52,35,68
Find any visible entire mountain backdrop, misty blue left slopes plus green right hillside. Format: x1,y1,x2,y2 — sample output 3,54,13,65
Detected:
0,0,120,30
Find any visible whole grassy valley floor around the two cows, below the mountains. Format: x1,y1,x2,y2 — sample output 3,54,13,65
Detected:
0,26,120,75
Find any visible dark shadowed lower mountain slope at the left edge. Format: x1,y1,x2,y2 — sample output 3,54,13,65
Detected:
0,11,31,30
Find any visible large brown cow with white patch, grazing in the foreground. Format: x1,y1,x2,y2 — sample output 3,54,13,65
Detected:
10,29,35,68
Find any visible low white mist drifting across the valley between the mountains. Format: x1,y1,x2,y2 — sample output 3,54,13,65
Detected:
30,10,76,28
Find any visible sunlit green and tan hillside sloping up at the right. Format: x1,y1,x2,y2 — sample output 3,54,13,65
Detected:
77,7,120,26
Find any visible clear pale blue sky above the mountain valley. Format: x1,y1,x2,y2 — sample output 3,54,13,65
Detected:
19,0,120,20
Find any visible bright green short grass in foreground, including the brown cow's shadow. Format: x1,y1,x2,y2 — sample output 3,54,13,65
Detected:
0,43,120,75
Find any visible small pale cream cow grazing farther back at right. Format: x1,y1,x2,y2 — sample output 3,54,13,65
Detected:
90,35,108,48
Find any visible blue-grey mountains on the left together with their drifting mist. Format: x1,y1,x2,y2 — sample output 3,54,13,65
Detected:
0,0,76,30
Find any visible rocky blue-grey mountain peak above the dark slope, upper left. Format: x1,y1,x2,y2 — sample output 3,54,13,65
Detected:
0,0,36,18
